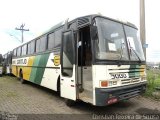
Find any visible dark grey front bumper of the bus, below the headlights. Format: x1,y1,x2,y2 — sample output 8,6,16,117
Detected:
95,82,147,106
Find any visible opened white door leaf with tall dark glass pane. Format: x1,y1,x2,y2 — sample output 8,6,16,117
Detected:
60,30,76,100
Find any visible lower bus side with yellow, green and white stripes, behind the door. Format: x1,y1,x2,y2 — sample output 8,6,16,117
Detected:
12,53,60,91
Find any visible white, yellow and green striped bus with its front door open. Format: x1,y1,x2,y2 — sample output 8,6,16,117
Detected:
12,15,146,106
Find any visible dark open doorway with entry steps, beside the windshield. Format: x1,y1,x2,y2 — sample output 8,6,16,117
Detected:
78,26,93,103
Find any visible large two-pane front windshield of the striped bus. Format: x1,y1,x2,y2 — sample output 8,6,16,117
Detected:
95,17,144,61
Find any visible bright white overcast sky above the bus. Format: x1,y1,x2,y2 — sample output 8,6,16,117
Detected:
0,0,160,62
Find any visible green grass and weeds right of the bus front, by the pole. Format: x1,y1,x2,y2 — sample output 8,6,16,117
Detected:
144,70,160,99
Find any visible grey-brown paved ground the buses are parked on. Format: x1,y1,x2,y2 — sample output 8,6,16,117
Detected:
0,76,160,120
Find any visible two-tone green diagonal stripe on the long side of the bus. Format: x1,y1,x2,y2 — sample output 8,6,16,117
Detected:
30,54,49,84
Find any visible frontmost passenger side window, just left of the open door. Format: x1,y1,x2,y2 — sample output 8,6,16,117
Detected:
54,29,62,48
